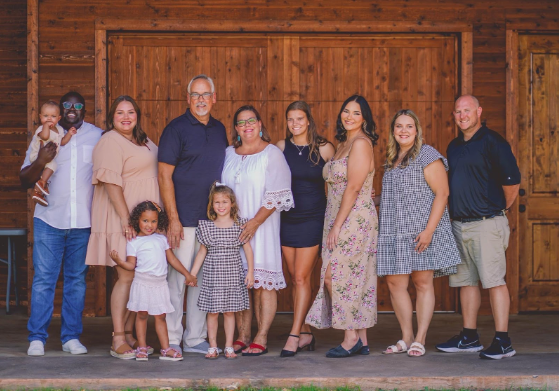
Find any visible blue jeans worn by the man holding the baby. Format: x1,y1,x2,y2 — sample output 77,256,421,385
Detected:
27,218,91,343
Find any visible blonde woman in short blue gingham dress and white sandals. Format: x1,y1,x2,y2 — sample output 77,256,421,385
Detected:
377,110,460,356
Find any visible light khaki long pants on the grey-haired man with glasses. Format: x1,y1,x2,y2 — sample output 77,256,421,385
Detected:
166,227,208,348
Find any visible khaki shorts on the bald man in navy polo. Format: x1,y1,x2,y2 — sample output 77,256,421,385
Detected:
450,216,510,289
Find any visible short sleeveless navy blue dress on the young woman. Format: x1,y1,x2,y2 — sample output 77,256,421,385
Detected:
280,139,326,248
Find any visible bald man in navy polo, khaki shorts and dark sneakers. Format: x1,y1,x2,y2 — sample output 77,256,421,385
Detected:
437,95,520,359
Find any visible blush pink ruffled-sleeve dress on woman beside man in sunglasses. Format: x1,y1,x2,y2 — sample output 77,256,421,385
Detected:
84,130,161,266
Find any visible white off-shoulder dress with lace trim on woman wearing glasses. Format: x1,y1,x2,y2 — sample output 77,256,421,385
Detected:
221,144,294,290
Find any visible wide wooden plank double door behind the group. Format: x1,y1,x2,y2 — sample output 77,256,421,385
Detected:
107,33,458,311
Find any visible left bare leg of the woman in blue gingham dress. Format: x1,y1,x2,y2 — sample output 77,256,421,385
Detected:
386,274,414,352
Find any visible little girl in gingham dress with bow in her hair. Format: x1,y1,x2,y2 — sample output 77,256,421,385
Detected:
191,182,254,359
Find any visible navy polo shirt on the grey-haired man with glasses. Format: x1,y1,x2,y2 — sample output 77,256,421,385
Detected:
158,109,229,227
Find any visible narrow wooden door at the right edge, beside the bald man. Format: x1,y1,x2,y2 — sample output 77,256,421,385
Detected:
518,35,559,311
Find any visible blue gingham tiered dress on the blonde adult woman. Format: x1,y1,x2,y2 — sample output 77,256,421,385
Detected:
377,145,461,277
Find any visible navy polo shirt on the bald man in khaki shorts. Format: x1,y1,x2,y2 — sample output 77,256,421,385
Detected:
446,126,520,219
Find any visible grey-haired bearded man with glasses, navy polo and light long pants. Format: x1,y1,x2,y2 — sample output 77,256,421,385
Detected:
159,75,229,354
